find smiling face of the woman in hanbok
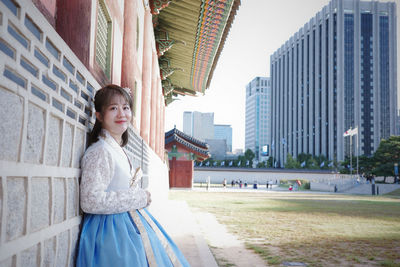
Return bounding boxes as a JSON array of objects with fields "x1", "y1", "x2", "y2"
[{"x1": 96, "y1": 95, "x2": 132, "y2": 144}]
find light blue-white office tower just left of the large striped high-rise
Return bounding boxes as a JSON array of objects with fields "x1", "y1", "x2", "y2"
[{"x1": 245, "y1": 77, "x2": 271, "y2": 160}]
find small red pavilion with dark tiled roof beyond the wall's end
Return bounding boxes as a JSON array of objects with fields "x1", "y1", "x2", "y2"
[{"x1": 165, "y1": 128, "x2": 210, "y2": 188}]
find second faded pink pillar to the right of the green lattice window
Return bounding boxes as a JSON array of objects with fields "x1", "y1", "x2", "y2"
[{"x1": 140, "y1": 10, "x2": 153, "y2": 144}]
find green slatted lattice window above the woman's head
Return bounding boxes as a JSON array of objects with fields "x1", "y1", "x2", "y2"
[{"x1": 96, "y1": 0, "x2": 112, "y2": 78}]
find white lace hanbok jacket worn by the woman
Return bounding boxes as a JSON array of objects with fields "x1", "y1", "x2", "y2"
[{"x1": 80, "y1": 129, "x2": 147, "y2": 214}]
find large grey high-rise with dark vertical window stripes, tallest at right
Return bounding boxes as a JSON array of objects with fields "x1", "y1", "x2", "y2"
[{"x1": 271, "y1": 0, "x2": 397, "y2": 165}]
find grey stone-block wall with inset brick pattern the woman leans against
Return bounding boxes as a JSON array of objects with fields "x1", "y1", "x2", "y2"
[{"x1": 0, "y1": 0, "x2": 168, "y2": 266}]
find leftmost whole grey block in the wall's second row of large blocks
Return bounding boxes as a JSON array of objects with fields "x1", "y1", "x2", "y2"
[{"x1": 5, "y1": 177, "x2": 27, "y2": 241}]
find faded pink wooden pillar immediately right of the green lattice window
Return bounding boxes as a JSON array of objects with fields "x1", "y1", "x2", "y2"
[{"x1": 121, "y1": 1, "x2": 137, "y2": 128}]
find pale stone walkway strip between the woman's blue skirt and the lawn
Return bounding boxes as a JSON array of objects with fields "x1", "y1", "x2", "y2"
[{"x1": 150, "y1": 200, "x2": 218, "y2": 267}]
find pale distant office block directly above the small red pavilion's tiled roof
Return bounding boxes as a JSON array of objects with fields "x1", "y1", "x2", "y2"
[{"x1": 183, "y1": 111, "x2": 214, "y2": 141}]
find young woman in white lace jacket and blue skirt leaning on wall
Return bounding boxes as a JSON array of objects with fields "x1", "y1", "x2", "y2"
[{"x1": 76, "y1": 85, "x2": 189, "y2": 267}]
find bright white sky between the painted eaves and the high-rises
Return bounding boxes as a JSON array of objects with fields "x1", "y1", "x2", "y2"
[{"x1": 165, "y1": 0, "x2": 400, "y2": 150}]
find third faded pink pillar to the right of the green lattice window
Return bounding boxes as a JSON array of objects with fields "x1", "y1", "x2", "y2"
[{"x1": 150, "y1": 51, "x2": 159, "y2": 151}]
